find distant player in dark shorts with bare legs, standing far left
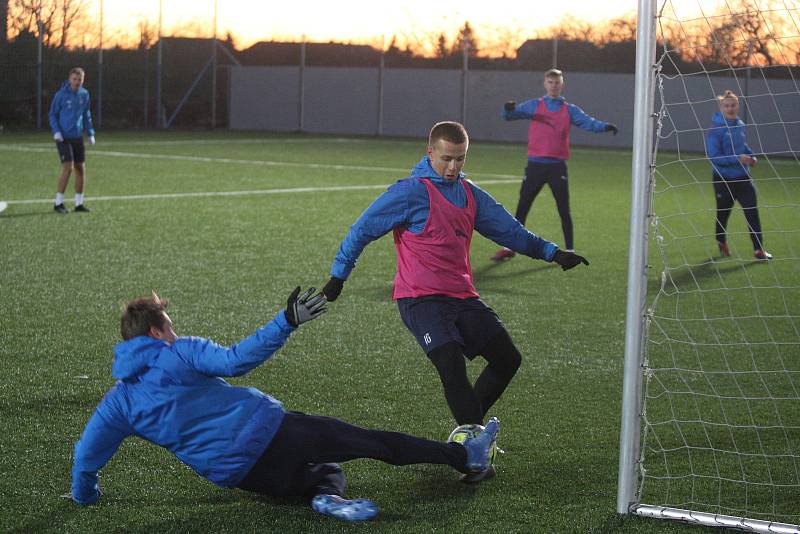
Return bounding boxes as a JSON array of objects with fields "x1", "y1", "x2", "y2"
[{"x1": 48, "y1": 67, "x2": 94, "y2": 215}]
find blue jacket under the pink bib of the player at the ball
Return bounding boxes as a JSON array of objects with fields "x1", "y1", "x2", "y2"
[{"x1": 331, "y1": 156, "x2": 558, "y2": 280}]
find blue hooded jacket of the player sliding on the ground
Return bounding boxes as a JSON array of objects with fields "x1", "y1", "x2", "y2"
[{"x1": 72, "y1": 311, "x2": 294, "y2": 504}]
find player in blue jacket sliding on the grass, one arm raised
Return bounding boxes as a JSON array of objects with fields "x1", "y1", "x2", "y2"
[{"x1": 69, "y1": 294, "x2": 499, "y2": 521}]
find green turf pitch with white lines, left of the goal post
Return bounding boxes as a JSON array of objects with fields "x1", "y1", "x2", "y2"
[{"x1": 0, "y1": 132, "x2": 800, "y2": 532}]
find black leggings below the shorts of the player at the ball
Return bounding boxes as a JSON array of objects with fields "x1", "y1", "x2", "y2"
[{"x1": 428, "y1": 330, "x2": 522, "y2": 425}]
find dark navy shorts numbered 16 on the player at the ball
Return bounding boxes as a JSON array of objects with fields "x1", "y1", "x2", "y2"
[{"x1": 397, "y1": 295, "x2": 505, "y2": 360}]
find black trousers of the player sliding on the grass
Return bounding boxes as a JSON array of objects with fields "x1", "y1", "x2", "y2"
[{"x1": 234, "y1": 412, "x2": 467, "y2": 499}]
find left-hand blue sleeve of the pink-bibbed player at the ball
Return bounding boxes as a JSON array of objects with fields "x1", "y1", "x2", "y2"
[{"x1": 331, "y1": 180, "x2": 411, "y2": 280}]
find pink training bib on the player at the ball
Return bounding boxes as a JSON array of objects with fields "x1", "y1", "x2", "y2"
[{"x1": 392, "y1": 179, "x2": 478, "y2": 300}]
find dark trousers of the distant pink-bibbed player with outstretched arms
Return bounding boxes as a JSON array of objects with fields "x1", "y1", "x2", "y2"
[{"x1": 515, "y1": 161, "x2": 574, "y2": 249}]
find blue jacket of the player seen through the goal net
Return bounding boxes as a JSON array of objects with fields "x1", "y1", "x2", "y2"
[{"x1": 706, "y1": 111, "x2": 753, "y2": 181}]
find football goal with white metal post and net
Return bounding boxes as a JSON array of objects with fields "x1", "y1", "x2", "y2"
[{"x1": 617, "y1": 0, "x2": 800, "y2": 534}]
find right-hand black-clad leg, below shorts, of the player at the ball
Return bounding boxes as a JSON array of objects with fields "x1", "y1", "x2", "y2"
[{"x1": 475, "y1": 329, "x2": 522, "y2": 416}]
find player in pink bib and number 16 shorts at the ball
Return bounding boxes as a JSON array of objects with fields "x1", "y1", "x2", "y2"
[{"x1": 323, "y1": 122, "x2": 589, "y2": 482}]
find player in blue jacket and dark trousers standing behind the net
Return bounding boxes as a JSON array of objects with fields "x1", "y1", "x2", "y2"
[{"x1": 706, "y1": 90, "x2": 772, "y2": 260}]
